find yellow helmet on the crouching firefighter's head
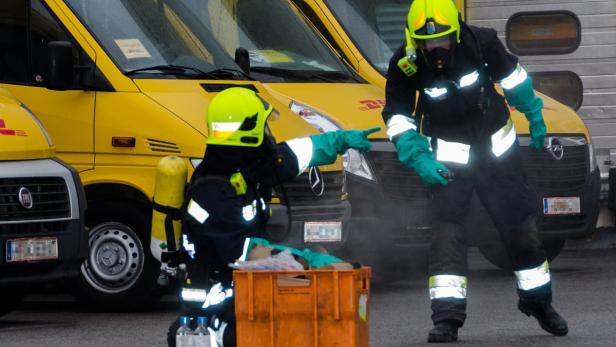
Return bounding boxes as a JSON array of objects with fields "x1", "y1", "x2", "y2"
[{"x1": 207, "y1": 87, "x2": 274, "y2": 147}]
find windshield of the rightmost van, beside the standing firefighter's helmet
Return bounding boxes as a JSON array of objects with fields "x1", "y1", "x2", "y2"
[{"x1": 324, "y1": 0, "x2": 412, "y2": 75}]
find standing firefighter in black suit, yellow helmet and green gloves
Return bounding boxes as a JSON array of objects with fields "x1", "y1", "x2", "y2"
[{"x1": 383, "y1": 0, "x2": 568, "y2": 342}]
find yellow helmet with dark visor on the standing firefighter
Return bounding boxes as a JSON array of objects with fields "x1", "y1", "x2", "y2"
[{"x1": 407, "y1": 0, "x2": 460, "y2": 46}]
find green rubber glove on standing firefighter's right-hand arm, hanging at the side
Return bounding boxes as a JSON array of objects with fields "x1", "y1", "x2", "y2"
[{"x1": 505, "y1": 76, "x2": 547, "y2": 152}]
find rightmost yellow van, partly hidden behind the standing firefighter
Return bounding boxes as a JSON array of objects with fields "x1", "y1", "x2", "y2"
[{"x1": 285, "y1": 0, "x2": 600, "y2": 276}]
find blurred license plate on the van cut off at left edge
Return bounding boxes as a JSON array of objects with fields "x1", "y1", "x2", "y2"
[{"x1": 6, "y1": 237, "x2": 58, "y2": 263}]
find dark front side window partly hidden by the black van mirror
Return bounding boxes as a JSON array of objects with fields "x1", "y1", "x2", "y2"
[{"x1": 30, "y1": 0, "x2": 79, "y2": 84}]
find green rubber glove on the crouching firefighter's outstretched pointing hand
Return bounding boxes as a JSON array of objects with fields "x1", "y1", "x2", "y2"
[{"x1": 308, "y1": 127, "x2": 381, "y2": 166}]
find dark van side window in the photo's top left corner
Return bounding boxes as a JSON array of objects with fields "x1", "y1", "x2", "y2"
[{"x1": 0, "y1": 0, "x2": 28, "y2": 83}]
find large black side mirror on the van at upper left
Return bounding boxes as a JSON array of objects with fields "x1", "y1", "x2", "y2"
[{"x1": 45, "y1": 41, "x2": 75, "y2": 90}]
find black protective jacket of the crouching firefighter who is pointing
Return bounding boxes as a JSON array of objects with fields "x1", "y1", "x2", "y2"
[{"x1": 182, "y1": 143, "x2": 299, "y2": 282}]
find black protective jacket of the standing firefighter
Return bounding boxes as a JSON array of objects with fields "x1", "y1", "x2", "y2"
[{"x1": 383, "y1": 23, "x2": 518, "y2": 148}]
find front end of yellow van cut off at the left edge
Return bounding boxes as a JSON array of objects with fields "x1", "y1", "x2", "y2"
[{"x1": 0, "y1": 88, "x2": 88, "y2": 315}]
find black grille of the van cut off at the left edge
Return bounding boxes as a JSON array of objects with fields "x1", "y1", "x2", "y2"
[{"x1": 0, "y1": 177, "x2": 71, "y2": 222}]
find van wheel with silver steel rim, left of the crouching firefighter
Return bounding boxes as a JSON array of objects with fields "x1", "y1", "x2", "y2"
[{"x1": 73, "y1": 201, "x2": 159, "y2": 311}]
